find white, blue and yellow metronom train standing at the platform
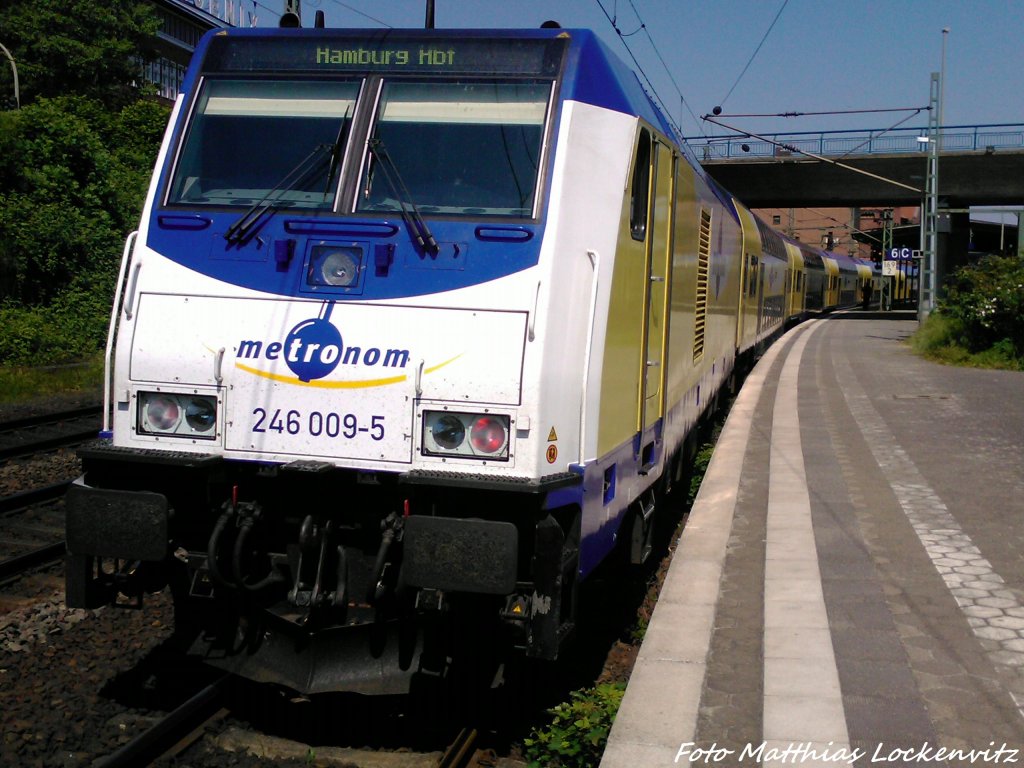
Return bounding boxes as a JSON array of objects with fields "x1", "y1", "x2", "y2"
[{"x1": 67, "y1": 18, "x2": 876, "y2": 693}]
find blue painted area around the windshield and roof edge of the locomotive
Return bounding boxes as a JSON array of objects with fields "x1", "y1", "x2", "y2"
[{"x1": 147, "y1": 29, "x2": 671, "y2": 300}]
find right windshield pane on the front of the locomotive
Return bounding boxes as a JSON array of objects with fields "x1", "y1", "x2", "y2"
[{"x1": 355, "y1": 81, "x2": 551, "y2": 217}]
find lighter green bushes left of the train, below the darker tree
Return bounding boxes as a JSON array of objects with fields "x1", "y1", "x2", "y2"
[{"x1": 0, "y1": 96, "x2": 168, "y2": 365}]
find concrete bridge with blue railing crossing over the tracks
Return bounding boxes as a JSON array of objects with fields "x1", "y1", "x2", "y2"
[{"x1": 687, "y1": 123, "x2": 1024, "y2": 290}]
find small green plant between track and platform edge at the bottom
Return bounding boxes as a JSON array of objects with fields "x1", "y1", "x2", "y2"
[{"x1": 523, "y1": 683, "x2": 626, "y2": 768}]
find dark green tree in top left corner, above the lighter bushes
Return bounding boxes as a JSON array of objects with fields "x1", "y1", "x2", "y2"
[{"x1": 0, "y1": 0, "x2": 160, "y2": 109}]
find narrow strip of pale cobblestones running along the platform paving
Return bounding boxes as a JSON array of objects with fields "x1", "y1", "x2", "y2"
[{"x1": 835, "y1": 350, "x2": 1024, "y2": 717}]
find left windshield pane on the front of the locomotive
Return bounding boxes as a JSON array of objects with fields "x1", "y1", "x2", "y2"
[{"x1": 167, "y1": 80, "x2": 359, "y2": 209}]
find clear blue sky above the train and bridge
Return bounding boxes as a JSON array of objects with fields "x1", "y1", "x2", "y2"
[{"x1": 244, "y1": 0, "x2": 1024, "y2": 143}]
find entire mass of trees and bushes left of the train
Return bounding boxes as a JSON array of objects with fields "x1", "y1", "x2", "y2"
[{"x1": 0, "y1": 0, "x2": 168, "y2": 367}]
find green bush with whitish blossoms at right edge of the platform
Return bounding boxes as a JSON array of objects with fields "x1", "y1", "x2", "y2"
[{"x1": 939, "y1": 256, "x2": 1024, "y2": 357}]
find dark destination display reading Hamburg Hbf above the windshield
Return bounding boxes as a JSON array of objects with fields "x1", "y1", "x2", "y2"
[{"x1": 203, "y1": 35, "x2": 566, "y2": 77}]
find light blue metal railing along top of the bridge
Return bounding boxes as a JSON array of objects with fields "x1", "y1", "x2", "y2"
[{"x1": 686, "y1": 123, "x2": 1024, "y2": 161}]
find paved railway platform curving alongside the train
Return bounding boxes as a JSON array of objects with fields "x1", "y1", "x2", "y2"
[{"x1": 601, "y1": 311, "x2": 1024, "y2": 768}]
